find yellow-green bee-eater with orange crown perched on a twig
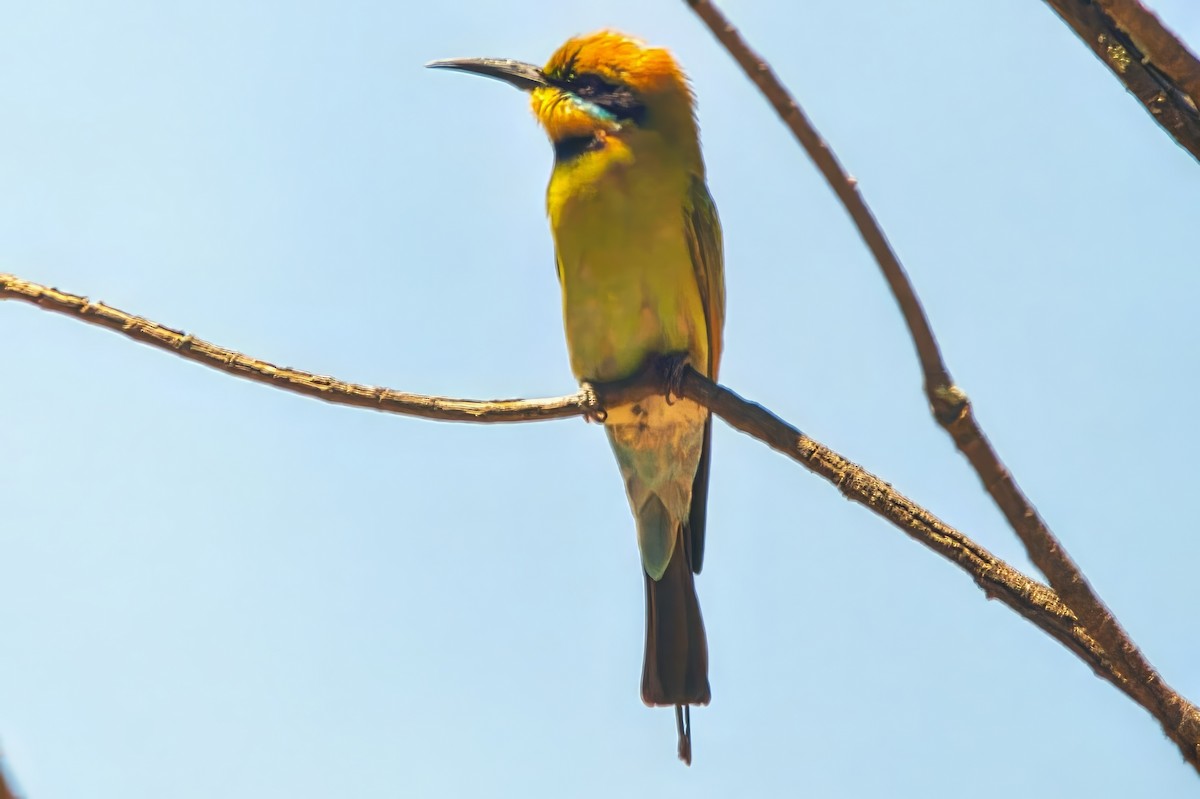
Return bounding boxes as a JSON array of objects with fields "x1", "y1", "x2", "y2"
[{"x1": 428, "y1": 31, "x2": 725, "y2": 763}]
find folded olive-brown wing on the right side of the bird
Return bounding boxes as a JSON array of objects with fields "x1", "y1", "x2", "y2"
[{"x1": 684, "y1": 175, "x2": 725, "y2": 575}]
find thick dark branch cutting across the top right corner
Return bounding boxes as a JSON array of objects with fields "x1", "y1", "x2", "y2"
[{"x1": 1045, "y1": 0, "x2": 1200, "y2": 160}]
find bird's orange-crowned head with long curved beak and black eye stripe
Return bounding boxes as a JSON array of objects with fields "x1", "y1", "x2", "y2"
[{"x1": 427, "y1": 30, "x2": 700, "y2": 158}]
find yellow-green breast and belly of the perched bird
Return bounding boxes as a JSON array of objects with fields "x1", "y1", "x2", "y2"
[{"x1": 547, "y1": 138, "x2": 708, "y2": 382}]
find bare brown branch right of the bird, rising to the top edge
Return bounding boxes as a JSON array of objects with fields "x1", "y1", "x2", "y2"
[{"x1": 685, "y1": 0, "x2": 1200, "y2": 771}]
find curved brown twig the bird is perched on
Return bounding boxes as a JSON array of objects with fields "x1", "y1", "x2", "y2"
[{"x1": 0, "y1": 275, "x2": 1129, "y2": 705}]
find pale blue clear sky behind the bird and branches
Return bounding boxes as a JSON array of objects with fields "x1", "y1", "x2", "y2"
[{"x1": 0, "y1": 0, "x2": 1200, "y2": 799}]
